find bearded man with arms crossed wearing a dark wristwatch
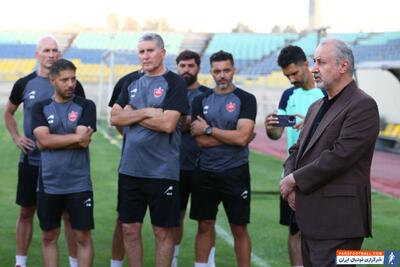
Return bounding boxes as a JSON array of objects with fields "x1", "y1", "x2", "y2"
[{"x1": 190, "y1": 51, "x2": 257, "y2": 267}]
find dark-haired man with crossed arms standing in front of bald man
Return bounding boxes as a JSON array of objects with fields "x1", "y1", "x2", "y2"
[{"x1": 32, "y1": 59, "x2": 96, "y2": 267}]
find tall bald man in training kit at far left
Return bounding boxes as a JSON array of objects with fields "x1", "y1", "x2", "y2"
[{"x1": 4, "y1": 36, "x2": 85, "y2": 267}]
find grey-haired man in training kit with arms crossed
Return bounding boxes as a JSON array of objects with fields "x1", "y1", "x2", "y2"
[{"x1": 111, "y1": 33, "x2": 189, "y2": 267}]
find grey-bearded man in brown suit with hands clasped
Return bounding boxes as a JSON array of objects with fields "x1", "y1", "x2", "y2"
[{"x1": 280, "y1": 40, "x2": 379, "y2": 267}]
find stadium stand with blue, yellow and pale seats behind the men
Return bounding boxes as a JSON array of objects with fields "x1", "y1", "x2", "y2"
[{"x1": 0, "y1": 31, "x2": 400, "y2": 127}]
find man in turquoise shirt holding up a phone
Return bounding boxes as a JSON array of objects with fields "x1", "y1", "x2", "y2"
[{"x1": 265, "y1": 45, "x2": 324, "y2": 266}]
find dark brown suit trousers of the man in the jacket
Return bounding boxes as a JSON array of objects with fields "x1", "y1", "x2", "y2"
[{"x1": 301, "y1": 234, "x2": 364, "y2": 267}]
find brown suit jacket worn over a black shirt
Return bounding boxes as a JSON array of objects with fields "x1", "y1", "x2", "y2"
[{"x1": 285, "y1": 81, "x2": 379, "y2": 239}]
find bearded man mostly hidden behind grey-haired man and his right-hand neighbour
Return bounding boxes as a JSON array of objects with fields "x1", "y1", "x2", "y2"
[{"x1": 172, "y1": 50, "x2": 215, "y2": 267}]
